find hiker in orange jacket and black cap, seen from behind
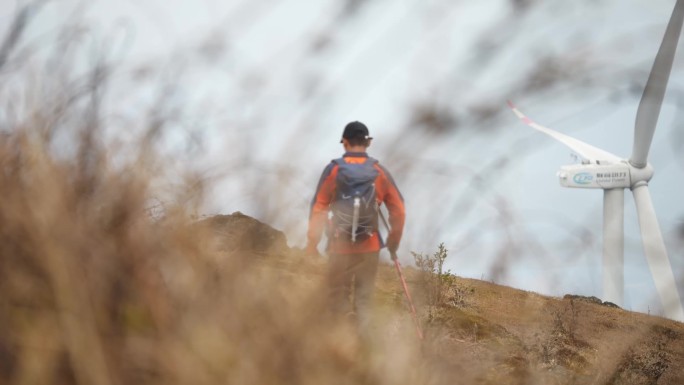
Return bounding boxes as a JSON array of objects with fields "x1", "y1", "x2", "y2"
[{"x1": 306, "y1": 121, "x2": 405, "y2": 332}]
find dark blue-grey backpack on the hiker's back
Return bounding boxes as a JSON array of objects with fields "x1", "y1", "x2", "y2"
[{"x1": 332, "y1": 157, "x2": 378, "y2": 243}]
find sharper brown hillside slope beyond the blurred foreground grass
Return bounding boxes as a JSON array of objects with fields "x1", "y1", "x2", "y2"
[{"x1": 203, "y1": 213, "x2": 684, "y2": 384}]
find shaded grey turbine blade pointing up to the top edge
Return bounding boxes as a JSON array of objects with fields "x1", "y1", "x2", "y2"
[{"x1": 629, "y1": 0, "x2": 684, "y2": 168}]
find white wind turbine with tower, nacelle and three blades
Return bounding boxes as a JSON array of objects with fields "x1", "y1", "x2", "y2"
[{"x1": 508, "y1": 0, "x2": 684, "y2": 321}]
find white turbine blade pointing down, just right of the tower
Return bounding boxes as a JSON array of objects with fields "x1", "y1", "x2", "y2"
[{"x1": 632, "y1": 183, "x2": 684, "y2": 322}]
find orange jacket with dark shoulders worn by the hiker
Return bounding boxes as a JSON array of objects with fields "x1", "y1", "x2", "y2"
[{"x1": 307, "y1": 152, "x2": 406, "y2": 254}]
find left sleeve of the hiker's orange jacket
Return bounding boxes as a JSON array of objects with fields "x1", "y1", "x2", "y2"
[{"x1": 306, "y1": 163, "x2": 337, "y2": 247}]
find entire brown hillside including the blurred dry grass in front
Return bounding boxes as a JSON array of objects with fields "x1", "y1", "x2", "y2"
[{"x1": 0, "y1": 202, "x2": 684, "y2": 385}]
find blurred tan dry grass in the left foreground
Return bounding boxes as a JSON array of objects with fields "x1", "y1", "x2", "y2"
[{"x1": 0, "y1": 91, "x2": 433, "y2": 384}]
